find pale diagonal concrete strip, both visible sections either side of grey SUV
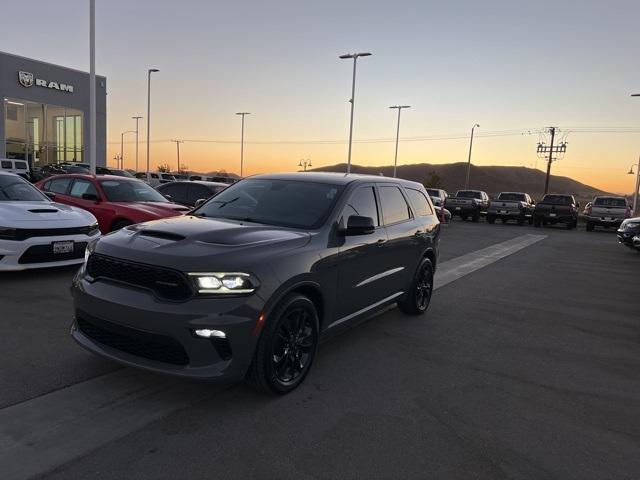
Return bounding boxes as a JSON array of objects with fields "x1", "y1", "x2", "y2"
[{"x1": 0, "y1": 235, "x2": 546, "y2": 480}]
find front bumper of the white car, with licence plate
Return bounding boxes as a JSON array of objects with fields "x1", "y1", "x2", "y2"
[{"x1": 0, "y1": 234, "x2": 98, "y2": 271}]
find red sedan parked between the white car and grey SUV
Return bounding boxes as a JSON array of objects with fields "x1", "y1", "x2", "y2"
[{"x1": 36, "y1": 174, "x2": 189, "y2": 233}]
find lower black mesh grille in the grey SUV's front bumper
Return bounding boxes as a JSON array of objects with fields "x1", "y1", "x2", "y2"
[{"x1": 76, "y1": 314, "x2": 189, "y2": 365}]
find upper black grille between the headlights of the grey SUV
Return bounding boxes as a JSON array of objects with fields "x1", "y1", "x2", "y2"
[{"x1": 87, "y1": 253, "x2": 193, "y2": 301}]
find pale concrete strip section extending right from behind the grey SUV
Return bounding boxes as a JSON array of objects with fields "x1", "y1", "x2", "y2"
[{"x1": 434, "y1": 234, "x2": 547, "y2": 290}]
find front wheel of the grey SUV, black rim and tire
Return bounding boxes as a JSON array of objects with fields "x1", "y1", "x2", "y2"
[{"x1": 247, "y1": 293, "x2": 320, "y2": 395}]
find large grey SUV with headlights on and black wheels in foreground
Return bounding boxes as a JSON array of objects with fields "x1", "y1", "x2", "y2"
[{"x1": 72, "y1": 172, "x2": 440, "y2": 393}]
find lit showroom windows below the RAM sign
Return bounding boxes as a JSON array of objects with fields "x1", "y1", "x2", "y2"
[{"x1": 4, "y1": 98, "x2": 84, "y2": 166}]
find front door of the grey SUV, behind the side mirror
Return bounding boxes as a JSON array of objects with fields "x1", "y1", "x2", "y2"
[{"x1": 335, "y1": 183, "x2": 389, "y2": 322}]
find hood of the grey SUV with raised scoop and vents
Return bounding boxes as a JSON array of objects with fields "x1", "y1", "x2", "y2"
[{"x1": 95, "y1": 215, "x2": 311, "y2": 272}]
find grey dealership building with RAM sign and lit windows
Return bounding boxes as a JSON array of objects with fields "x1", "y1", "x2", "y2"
[{"x1": 0, "y1": 52, "x2": 107, "y2": 166}]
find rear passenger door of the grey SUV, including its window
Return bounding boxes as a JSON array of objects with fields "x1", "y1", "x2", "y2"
[{"x1": 378, "y1": 183, "x2": 427, "y2": 292}]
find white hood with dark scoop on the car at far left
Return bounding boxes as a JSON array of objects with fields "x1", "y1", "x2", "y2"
[{"x1": 0, "y1": 201, "x2": 96, "y2": 228}]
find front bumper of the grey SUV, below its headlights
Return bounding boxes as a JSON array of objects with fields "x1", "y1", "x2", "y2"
[{"x1": 71, "y1": 272, "x2": 264, "y2": 382}]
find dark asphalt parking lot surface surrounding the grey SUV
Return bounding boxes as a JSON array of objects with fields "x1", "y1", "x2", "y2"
[{"x1": 0, "y1": 221, "x2": 640, "y2": 480}]
